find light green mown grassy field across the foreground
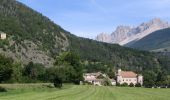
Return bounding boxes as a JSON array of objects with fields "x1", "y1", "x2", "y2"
[{"x1": 0, "y1": 84, "x2": 170, "y2": 100}]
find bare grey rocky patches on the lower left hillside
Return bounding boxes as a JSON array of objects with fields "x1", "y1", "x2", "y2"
[{"x1": 0, "y1": 32, "x2": 69, "y2": 67}]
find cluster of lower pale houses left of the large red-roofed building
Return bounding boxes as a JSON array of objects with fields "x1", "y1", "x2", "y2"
[{"x1": 83, "y1": 72, "x2": 116, "y2": 86}]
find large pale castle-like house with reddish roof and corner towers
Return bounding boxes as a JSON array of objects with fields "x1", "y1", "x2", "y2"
[{"x1": 117, "y1": 69, "x2": 143, "y2": 85}]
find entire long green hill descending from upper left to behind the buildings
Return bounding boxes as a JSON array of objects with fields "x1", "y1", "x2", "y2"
[{"x1": 0, "y1": 0, "x2": 169, "y2": 75}]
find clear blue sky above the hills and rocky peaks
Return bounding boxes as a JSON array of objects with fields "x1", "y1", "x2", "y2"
[{"x1": 18, "y1": 0, "x2": 170, "y2": 39}]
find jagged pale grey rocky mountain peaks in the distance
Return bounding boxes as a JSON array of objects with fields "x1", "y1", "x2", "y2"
[{"x1": 96, "y1": 18, "x2": 170, "y2": 45}]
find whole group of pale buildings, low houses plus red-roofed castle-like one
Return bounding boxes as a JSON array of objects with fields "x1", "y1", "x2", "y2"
[{"x1": 83, "y1": 69, "x2": 143, "y2": 87}]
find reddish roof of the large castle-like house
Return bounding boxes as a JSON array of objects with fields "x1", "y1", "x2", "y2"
[{"x1": 120, "y1": 71, "x2": 137, "y2": 78}]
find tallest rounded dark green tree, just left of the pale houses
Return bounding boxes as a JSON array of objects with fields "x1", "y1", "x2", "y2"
[{"x1": 55, "y1": 52, "x2": 83, "y2": 84}]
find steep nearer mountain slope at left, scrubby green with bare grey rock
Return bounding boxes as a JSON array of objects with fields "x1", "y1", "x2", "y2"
[{"x1": 0, "y1": 0, "x2": 68, "y2": 65}]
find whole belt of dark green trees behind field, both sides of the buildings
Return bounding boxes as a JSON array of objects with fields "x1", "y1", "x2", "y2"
[{"x1": 0, "y1": 52, "x2": 170, "y2": 87}]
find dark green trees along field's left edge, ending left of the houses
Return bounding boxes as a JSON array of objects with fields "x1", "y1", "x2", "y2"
[{"x1": 0, "y1": 52, "x2": 83, "y2": 87}]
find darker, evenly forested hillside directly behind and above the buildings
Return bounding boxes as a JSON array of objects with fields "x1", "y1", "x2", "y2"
[{"x1": 69, "y1": 33, "x2": 159, "y2": 71}]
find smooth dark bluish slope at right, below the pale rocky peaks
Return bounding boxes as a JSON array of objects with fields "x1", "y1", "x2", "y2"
[{"x1": 126, "y1": 28, "x2": 170, "y2": 51}]
